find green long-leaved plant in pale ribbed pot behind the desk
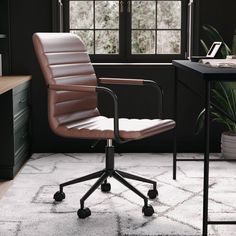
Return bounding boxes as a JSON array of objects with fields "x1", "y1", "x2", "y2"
[{"x1": 196, "y1": 25, "x2": 236, "y2": 159}]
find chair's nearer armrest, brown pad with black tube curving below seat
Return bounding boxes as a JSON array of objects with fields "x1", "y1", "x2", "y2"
[{"x1": 48, "y1": 84, "x2": 126, "y2": 143}]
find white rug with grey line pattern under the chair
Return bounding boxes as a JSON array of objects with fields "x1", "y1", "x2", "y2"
[{"x1": 0, "y1": 153, "x2": 236, "y2": 236}]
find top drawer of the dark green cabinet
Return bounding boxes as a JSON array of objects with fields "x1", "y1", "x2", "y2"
[{"x1": 13, "y1": 87, "x2": 30, "y2": 117}]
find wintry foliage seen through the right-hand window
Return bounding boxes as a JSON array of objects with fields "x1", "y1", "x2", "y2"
[{"x1": 131, "y1": 1, "x2": 181, "y2": 54}]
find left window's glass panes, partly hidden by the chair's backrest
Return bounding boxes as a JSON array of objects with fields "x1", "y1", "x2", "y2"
[{"x1": 69, "y1": 0, "x2": 119, "y2": 54}]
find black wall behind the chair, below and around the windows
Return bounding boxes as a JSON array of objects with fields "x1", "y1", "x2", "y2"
[{"x1": 0, "y1": 0, "x2": 236, "y2": 152}]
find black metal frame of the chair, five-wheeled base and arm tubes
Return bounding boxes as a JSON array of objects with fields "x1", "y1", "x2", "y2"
[{"x1": 53, "y1": 80, "x2": 176, "y2": 218}]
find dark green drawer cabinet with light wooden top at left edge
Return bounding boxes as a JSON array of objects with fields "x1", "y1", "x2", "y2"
[{"x1": 0, "y1": 76, "x2": 30, "y2": 179}]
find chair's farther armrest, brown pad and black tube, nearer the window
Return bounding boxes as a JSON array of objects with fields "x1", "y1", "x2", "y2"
[{"x1": 98, "y1": 78, "x2": 164, "y2": 118}]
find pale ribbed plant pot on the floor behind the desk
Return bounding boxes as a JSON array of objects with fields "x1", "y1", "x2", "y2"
[{"x1": 221, "y1": 132, "x2": 236, "y2": 159}]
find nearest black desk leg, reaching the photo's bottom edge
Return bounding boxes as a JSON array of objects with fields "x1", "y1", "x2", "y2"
[{"x1": 202, "y1": 81, "x2": 211, "y2": 236}]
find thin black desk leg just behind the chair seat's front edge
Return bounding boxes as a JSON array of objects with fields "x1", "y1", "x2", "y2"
[{"x1": 173, "y1": 67, "x2": 178, "y2": 179}]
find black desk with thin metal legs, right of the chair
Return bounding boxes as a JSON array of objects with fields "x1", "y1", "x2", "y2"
[{"x1": 172, "y1": 60, "x2": 236, "y2": 236}]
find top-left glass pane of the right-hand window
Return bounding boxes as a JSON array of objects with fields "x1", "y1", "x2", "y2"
[{"x1": 132, "y1": 1, "x2": 156, "y2": 29}]
